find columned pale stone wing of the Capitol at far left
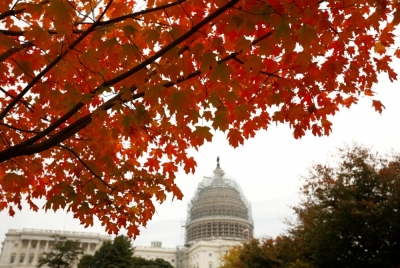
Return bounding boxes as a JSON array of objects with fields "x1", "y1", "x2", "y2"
[{"x1": 0, "y1": 229, "x2": 111, "y2": 268}]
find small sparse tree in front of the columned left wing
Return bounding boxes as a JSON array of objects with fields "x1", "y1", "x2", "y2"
[{"x1": 37, "y1": 236, "x2": 83, "y2": 268}]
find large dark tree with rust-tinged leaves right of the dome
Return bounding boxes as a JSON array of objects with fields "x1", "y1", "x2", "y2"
[{"x1": 221, "y1": 145, "x2": 400, "y2": 268}]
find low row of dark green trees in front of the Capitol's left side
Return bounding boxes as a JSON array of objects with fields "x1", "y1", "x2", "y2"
[{"x1": 37, "y1": 236, "x2": 173, "y2": 268}]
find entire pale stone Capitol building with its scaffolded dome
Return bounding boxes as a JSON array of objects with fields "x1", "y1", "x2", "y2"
[{"x1": 0, "y1": 158, "x2": 254, "y2": 268}]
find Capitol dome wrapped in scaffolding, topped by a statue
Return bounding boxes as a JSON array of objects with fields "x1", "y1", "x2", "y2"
[{"x1": 186, "y1": 165, "x2": 253, "y2": 243}]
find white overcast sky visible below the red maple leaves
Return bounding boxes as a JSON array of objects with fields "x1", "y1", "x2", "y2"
[{"x1": 0, "y1": 64, "x2": 400, "y2": 247}]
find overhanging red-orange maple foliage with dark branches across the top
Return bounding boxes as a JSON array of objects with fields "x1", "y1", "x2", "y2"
[{"x1": 0, "y1": 0, "x2": 400, "y2": 236}]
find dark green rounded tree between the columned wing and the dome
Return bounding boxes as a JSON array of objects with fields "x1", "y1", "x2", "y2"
[{"x1": 78, "y1": 236, "x2": 134, "y2": 268}]
